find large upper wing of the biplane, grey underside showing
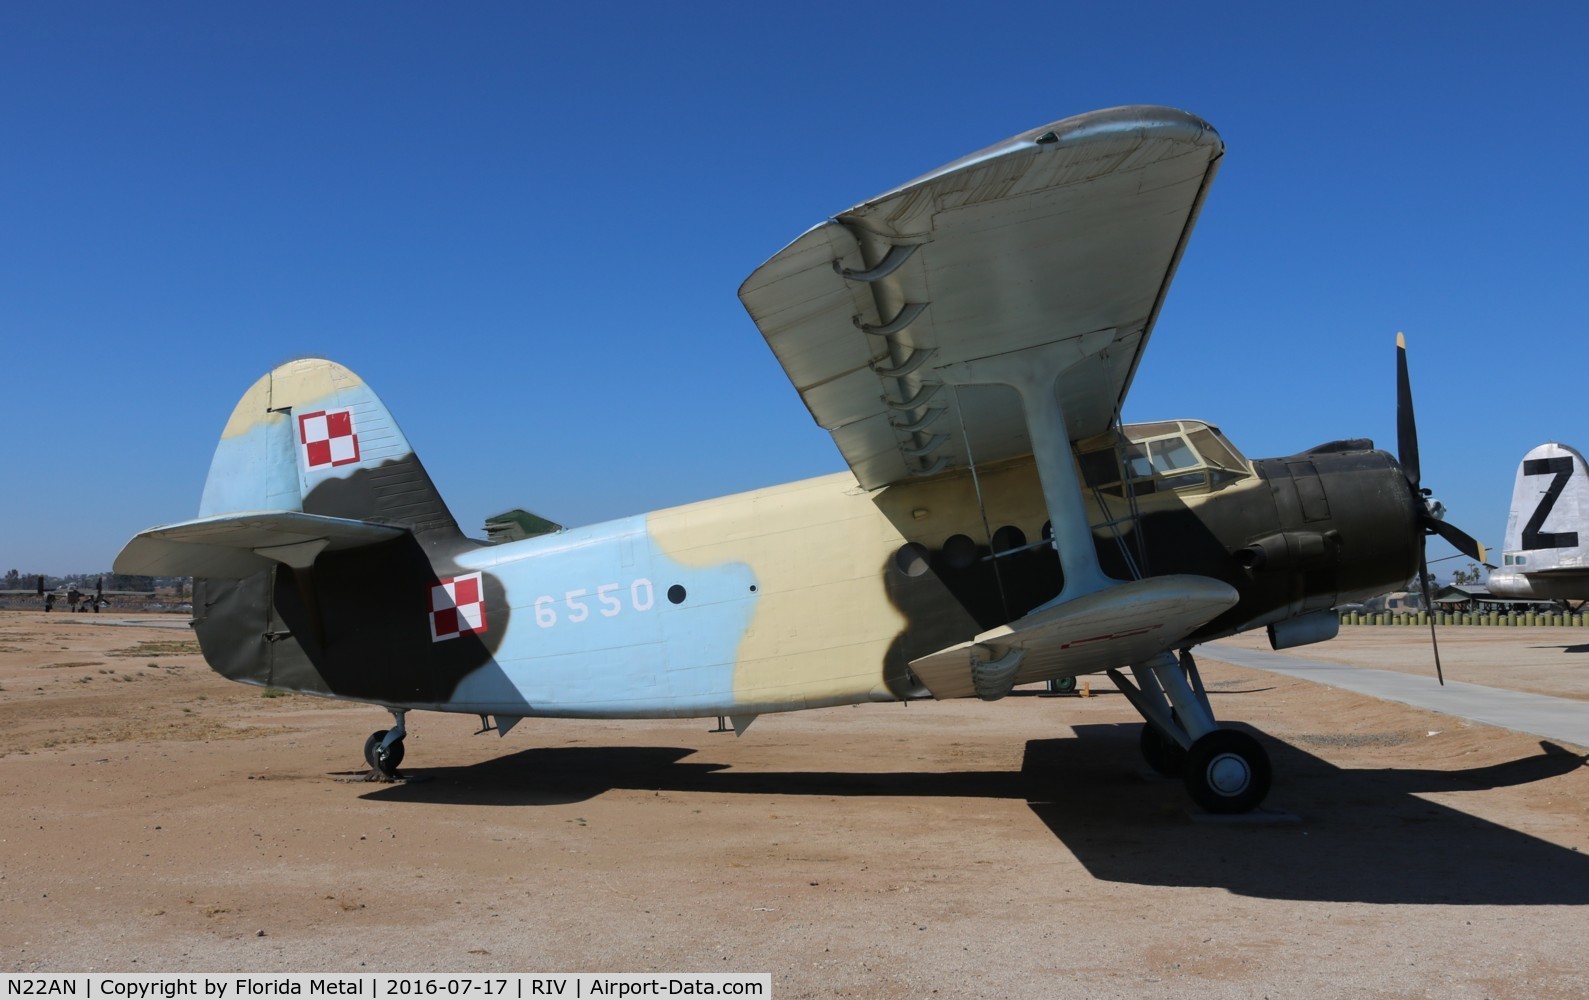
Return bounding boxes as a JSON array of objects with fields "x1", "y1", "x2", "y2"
[{"x1": 739, "y1": 107, "x2": 1225, "y2": 488}]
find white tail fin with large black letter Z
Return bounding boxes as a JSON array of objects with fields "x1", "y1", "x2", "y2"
[{"x1": 1502, "y1": 444, "x2": 1589, "y2": 576}]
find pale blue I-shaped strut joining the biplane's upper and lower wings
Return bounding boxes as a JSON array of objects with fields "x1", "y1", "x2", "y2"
[{"x1": 938, "y1": 328, "x2": 1117, "y2": 614}]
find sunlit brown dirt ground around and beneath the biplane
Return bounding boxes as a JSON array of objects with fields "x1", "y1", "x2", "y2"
[{"x1": 0, "y1": 612, "x2": 1589, "y2": 998}]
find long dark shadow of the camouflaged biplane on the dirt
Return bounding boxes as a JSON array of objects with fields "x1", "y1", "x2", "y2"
[{"x1": 367, "y1": 723, "x2": 1589, "y2": 906}]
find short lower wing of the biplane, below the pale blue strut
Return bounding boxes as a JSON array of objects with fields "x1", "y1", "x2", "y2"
[{"x1": 910, "y1": 576, "x2": 1239, "y2": 700}]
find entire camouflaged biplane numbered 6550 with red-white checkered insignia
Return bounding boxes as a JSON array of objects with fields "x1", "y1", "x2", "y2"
[{"x1": 116, "y1": 107, "x2": 1483, "y2": 812}]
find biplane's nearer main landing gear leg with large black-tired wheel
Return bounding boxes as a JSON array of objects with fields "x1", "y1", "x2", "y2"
[{"x1": 1109, "y1": 650, "x2": 1271, "y2": 812}]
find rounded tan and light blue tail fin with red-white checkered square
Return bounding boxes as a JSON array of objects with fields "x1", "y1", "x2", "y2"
[{"x1": 199, "y1": 358, "x2": 459, "y2": 536}]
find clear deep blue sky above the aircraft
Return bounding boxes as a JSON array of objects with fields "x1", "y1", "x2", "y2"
[{"x1": 0, "y1": 0, "x2": 1589, "y2": 572}]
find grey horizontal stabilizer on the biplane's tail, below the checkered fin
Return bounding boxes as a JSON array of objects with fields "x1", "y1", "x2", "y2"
[{"x1": 114, "y1": 510, "x2": 407, "y2": 580}]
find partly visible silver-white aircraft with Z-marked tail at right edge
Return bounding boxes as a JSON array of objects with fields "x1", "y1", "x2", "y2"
[{"x1": 1487, "y1": 442, "x2": 1589, "y2": 604}]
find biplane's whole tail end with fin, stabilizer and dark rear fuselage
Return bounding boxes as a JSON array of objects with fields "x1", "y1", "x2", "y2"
[{"x1": 116, "y1": 359, "x2": 489, "y2": 704}]
